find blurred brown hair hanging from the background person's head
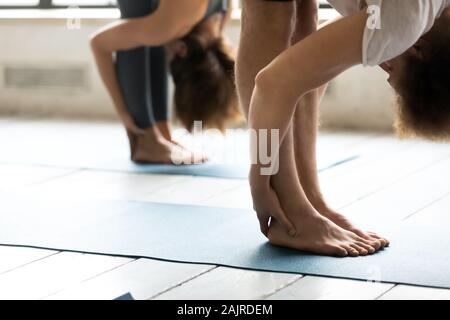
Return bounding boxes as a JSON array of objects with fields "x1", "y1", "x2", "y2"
[{"x1": 170, "y1": 31, "x2": 242, "y2": 131}]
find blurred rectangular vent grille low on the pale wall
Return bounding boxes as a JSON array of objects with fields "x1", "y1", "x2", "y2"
[{"x1": 3, "y1": 66, "x2": 87, "y2": 89}]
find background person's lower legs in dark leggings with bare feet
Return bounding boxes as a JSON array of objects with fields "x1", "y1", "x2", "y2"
[{"x1": 122, "y1": 47, "x2": 206, "y2": 164}]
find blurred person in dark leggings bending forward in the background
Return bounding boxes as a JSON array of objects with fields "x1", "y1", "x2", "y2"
[{"x1": 91, "y1": 0, "x2": 240, "y2": 164}]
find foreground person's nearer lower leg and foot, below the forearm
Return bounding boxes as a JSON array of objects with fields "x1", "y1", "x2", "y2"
[{"x1": 268, "y1": 129, "x2": 378, "y2": 256}]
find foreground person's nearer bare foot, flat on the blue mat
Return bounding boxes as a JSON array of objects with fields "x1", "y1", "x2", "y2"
[{"x1": 268, "y1": 211, "x2": 377, "y2": 257}]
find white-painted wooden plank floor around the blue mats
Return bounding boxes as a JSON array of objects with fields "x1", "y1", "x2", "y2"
[{"x1": 0, "y1": 119, "x2": 450, "y2": 300}]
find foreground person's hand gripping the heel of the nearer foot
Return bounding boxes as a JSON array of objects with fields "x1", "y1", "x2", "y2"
[{"x1": 250, "y1": 166, "x2": 297, "y2": 237}]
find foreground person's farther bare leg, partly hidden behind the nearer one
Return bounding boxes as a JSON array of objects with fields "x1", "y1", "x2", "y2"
[{"x1": 292, "y1": 1, "x2": 389, "y2": 249}]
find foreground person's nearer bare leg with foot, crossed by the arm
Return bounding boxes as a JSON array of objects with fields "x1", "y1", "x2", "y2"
[{"x1": 236, "y1": 0, "x2": 375, "y2": 256}]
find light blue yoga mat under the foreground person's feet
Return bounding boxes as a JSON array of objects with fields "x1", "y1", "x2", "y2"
[{"x1": 0, "y1": 196, "x2": 450, "y2": 288}]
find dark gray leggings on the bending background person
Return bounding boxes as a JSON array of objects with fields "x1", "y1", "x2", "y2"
[{"x1": 116, "y1": 0, "x2": 169, "y2": 129}]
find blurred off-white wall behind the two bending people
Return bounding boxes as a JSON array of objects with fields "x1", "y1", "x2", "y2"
[{"x1": 0, "y1": 13, "x2": 392, "y2": 129}]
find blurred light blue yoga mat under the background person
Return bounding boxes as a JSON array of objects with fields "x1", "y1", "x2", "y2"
[{"x1": 0, "y1": 122, "x2": 358, "y2": 179}]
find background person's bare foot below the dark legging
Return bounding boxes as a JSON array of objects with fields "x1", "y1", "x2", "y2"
[{"x1": 132, "y1": 136, "x2": 207, "y2": 165}]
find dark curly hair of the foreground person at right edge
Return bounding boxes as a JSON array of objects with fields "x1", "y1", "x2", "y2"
[{"x1": 396, "y1": 21, "x2": 450, "y2": 141}]
